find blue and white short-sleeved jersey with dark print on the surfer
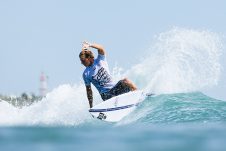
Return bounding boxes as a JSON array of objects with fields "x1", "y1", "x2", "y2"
[{"x1": 83, "y1": 54, "x2": 116, "y2": 93}]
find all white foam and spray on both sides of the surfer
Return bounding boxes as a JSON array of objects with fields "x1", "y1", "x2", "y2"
[{"x1": 0, "y1": 27, "x2": 222, "y2": 126}]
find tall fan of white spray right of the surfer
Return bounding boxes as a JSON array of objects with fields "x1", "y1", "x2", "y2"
[{"x1": 125, "y1": 28, "x2": 222, "y2": 93}]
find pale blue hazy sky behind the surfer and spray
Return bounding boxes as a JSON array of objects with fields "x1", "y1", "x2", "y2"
[{"x1": 0, "y1": 0, "x2": 226, "y2": 100}]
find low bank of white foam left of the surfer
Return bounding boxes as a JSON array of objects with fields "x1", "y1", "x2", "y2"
[{"x1": 0, "y1": 84, "x2": 91, "y2": 126}]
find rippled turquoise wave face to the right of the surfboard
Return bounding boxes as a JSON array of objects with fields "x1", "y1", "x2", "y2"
[{"x1": 119, "y1": 92, "x2": 226, "y2": 125}]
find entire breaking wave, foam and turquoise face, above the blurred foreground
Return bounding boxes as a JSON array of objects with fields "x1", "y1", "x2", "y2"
[{"x1": 0, "y1": 28, "x2": 226, "y2": 126}]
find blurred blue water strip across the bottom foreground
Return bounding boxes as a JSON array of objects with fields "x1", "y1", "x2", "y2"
[{"x1": 0, "y1": 125, "x2": 226, "y2": 151}]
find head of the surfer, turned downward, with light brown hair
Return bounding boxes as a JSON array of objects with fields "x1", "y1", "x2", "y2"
[{"x1": 79, "y1": 50, "x2": 94, "y2": 67}]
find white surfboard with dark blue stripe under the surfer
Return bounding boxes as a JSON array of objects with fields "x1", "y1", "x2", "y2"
[{"x1": 89, "y1": 91, "x2": 151, "y2": 122}]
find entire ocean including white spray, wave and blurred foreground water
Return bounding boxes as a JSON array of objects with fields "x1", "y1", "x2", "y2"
[{"x1": 0, "y1": 28, "x2": 226, "y2": 151}]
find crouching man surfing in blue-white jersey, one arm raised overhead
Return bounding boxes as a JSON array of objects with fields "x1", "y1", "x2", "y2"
[{"x1": 79, "y1": 42, "x2": 137, "y2": 108}]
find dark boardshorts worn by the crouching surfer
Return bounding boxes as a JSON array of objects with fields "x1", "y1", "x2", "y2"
[{"x1": 100, "y1": 80, "x2": 131, "y2": 101}]
